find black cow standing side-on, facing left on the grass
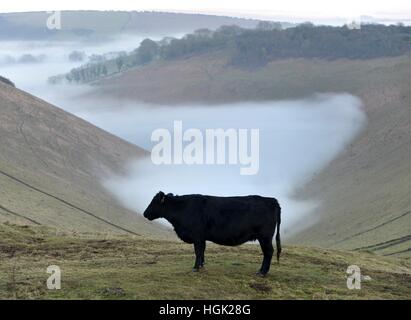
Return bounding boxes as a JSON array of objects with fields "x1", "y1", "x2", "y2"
[{"x1": 144, "y1": 191, "x2": 281, "y2": 276}]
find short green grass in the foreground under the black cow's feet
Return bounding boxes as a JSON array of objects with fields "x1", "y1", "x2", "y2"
[{"x1": 0, "y1": 224, "x2": 411, "y2": 299}]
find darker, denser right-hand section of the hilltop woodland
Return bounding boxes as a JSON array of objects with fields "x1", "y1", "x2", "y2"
[{"x1": 232, "y1": 24, "x2": 411, "y2": 66}]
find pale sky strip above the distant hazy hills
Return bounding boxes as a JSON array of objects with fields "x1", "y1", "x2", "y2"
[{"x1": 0, "y1": 0, "x2": 411, "y2": 20}]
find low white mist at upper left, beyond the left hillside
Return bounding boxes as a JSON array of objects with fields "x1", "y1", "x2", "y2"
[{"x1": 0, "y1": 34, "x2": 182, "y2": 96}]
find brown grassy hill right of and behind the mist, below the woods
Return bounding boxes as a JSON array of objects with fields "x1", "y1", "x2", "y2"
[{"x1": 91, "y1": 53, "x2": 411, "y2": 256}]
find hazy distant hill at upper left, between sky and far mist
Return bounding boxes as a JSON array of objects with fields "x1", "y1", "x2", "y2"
[{"x1": 0, "y1": 11, "x2": 264, "y2": 40}]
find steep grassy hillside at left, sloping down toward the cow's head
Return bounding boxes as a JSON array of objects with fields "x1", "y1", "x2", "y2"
[{"x1": 0, "y1": 82, "x2": 169, "y2": 241}]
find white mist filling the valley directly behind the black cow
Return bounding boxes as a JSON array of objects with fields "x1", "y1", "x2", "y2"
[{"x1": 71, "y1": 94, "x2": 365, "y2": 235}]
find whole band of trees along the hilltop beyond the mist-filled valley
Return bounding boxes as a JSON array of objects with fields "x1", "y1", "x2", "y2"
[{"x1": 49, "y1": 22, "x2": 411, "y2": 82}]
